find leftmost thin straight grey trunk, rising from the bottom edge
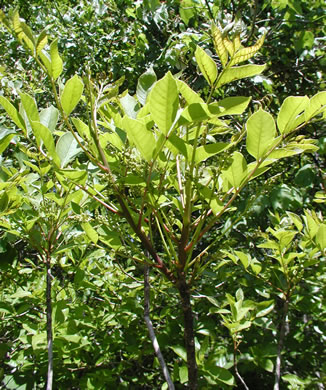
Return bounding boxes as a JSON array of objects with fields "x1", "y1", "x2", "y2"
[{"x1": 46, "y1": 256, "x2": 53, "y2": 390}]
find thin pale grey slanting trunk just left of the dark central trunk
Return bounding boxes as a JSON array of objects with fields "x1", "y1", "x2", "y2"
[{"x1": 144, "y1": 265, "x2": 174, "y2": 390}]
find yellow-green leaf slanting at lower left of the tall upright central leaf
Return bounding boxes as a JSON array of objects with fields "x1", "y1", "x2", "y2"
[{"x1": 122, "y1": 116, "x2": 155, "y2": 161}]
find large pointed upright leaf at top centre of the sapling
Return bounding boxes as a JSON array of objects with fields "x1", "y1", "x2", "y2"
[{"x1": 148, "y1": 72, "x2": 179, "y2": 135}]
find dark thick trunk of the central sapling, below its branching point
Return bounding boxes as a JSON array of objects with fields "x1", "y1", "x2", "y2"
[{"x1": 177, "y1": 273, "x2": 198, "y2": 390}]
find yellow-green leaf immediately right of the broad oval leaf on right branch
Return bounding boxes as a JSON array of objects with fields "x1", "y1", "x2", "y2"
[{"x1": 277, "y1": 96, "x2": 309, "y2": 134}]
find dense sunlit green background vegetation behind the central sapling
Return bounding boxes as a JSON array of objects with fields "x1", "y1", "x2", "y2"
[{"x1": 0, "y1": 0, "x2": 326, "y2": 390}]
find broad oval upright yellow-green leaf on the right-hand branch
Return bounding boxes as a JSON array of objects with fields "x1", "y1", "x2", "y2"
[{"x1": 246, "y1": 110, "x2": 276, "y2": 160}]
